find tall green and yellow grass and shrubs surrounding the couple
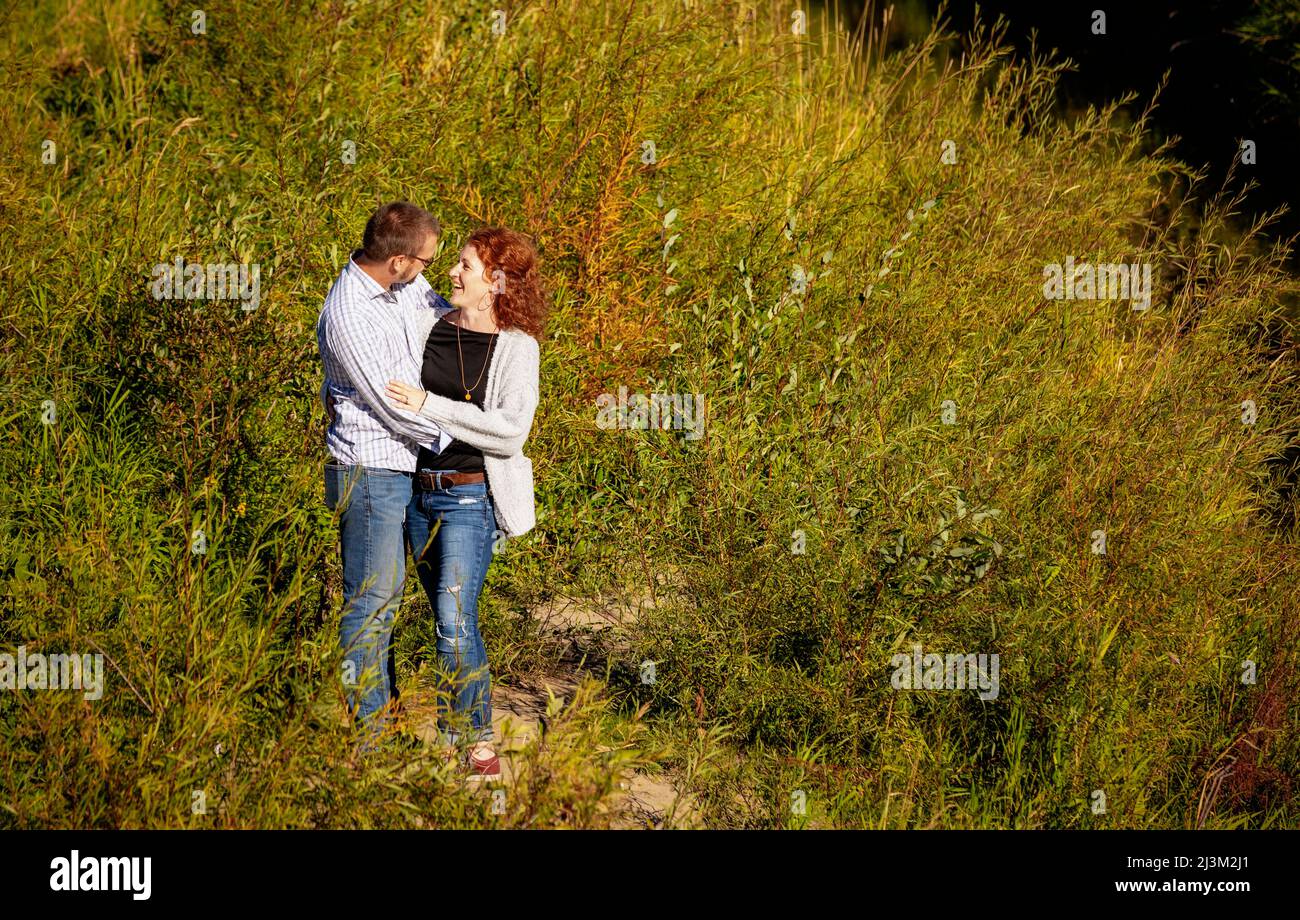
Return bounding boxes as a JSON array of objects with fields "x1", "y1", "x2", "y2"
[{"x1": 0, "y1": 0, "x2": 1300, "y2": 828}]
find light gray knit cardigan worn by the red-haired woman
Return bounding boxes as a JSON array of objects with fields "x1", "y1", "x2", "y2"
[{"x1": 420, "y1": 309, "x2": 541, "y2": 537}]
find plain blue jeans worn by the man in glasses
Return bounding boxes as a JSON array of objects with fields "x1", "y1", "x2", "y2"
[{"x1": 325, "y1": 463, "x2": 412, "y2": 743}]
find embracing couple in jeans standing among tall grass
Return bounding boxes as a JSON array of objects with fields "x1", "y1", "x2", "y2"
[{"x1": 316, "y1": 201, "x2": 545, "y2": 777}]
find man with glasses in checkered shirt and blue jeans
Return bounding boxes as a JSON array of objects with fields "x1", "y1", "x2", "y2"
[{"x1": 316, "y1": 201, "x2": 452, "y2": 748}]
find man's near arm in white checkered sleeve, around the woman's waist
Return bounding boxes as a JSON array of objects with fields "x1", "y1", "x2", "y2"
[{"x1": 325, "y1": 311, "x2": 452, "y2": 454}]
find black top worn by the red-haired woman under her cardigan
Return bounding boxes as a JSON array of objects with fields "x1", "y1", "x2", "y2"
[{"x1": 416, "y1": 318, "x2": 497, "y2": 473}]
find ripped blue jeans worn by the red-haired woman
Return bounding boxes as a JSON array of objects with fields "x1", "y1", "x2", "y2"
[{"x1": 406, "y1": 470, "x2": 498, "y2": 743}]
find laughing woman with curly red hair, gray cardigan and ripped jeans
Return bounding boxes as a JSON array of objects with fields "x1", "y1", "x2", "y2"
[{"x1": 387, "y1": 227, "x2": 545, "y2": 777}]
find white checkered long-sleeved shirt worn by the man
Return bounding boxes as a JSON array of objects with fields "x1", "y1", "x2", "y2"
[{"x1": 316, "y1": 249, "x2": 452, "y2": 472}]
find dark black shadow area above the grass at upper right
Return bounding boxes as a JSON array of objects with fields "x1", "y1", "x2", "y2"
[{"x1": 827, "y1": 0, "x2": 1300, "y2": 270}]
